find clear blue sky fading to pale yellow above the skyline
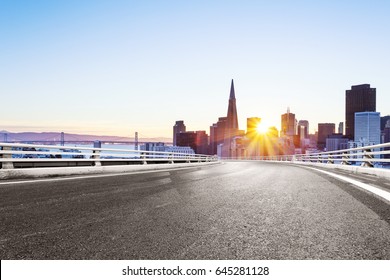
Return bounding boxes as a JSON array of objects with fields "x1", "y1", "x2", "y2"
[{"x1": 0, "y1": 0, "x2": 390, "y2": 137}]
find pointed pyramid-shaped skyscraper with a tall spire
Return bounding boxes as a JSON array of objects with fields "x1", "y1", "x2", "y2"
[{"x1": 222, "y1": 80, "x2": 240, "y2": 157}]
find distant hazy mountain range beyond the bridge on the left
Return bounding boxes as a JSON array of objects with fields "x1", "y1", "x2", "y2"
[{"x1": 0, "y1": 130, "x2": 172, "y2": 143}]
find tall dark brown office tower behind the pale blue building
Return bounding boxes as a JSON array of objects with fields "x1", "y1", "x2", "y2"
[{"x1": 345, "y1": 84, "x2": 376, "y2": 140}]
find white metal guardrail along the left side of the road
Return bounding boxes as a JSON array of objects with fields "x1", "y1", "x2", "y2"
[{"x1": 0, "y1": 143, "x2": 218, "y2": 169}]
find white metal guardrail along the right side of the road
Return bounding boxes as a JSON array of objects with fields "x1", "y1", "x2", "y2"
[{"x1": 224, "y1": 142, "x2": 390, "y2": 167}]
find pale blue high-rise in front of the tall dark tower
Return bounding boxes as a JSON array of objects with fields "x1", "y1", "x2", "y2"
[{"x1": 354, "y1": 112, "x2": 381, "y2": 145}]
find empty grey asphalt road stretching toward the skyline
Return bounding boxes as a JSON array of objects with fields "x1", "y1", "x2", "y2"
[{"x1": 0, "y1": 162, "x2": 390, "y2": 260}]
